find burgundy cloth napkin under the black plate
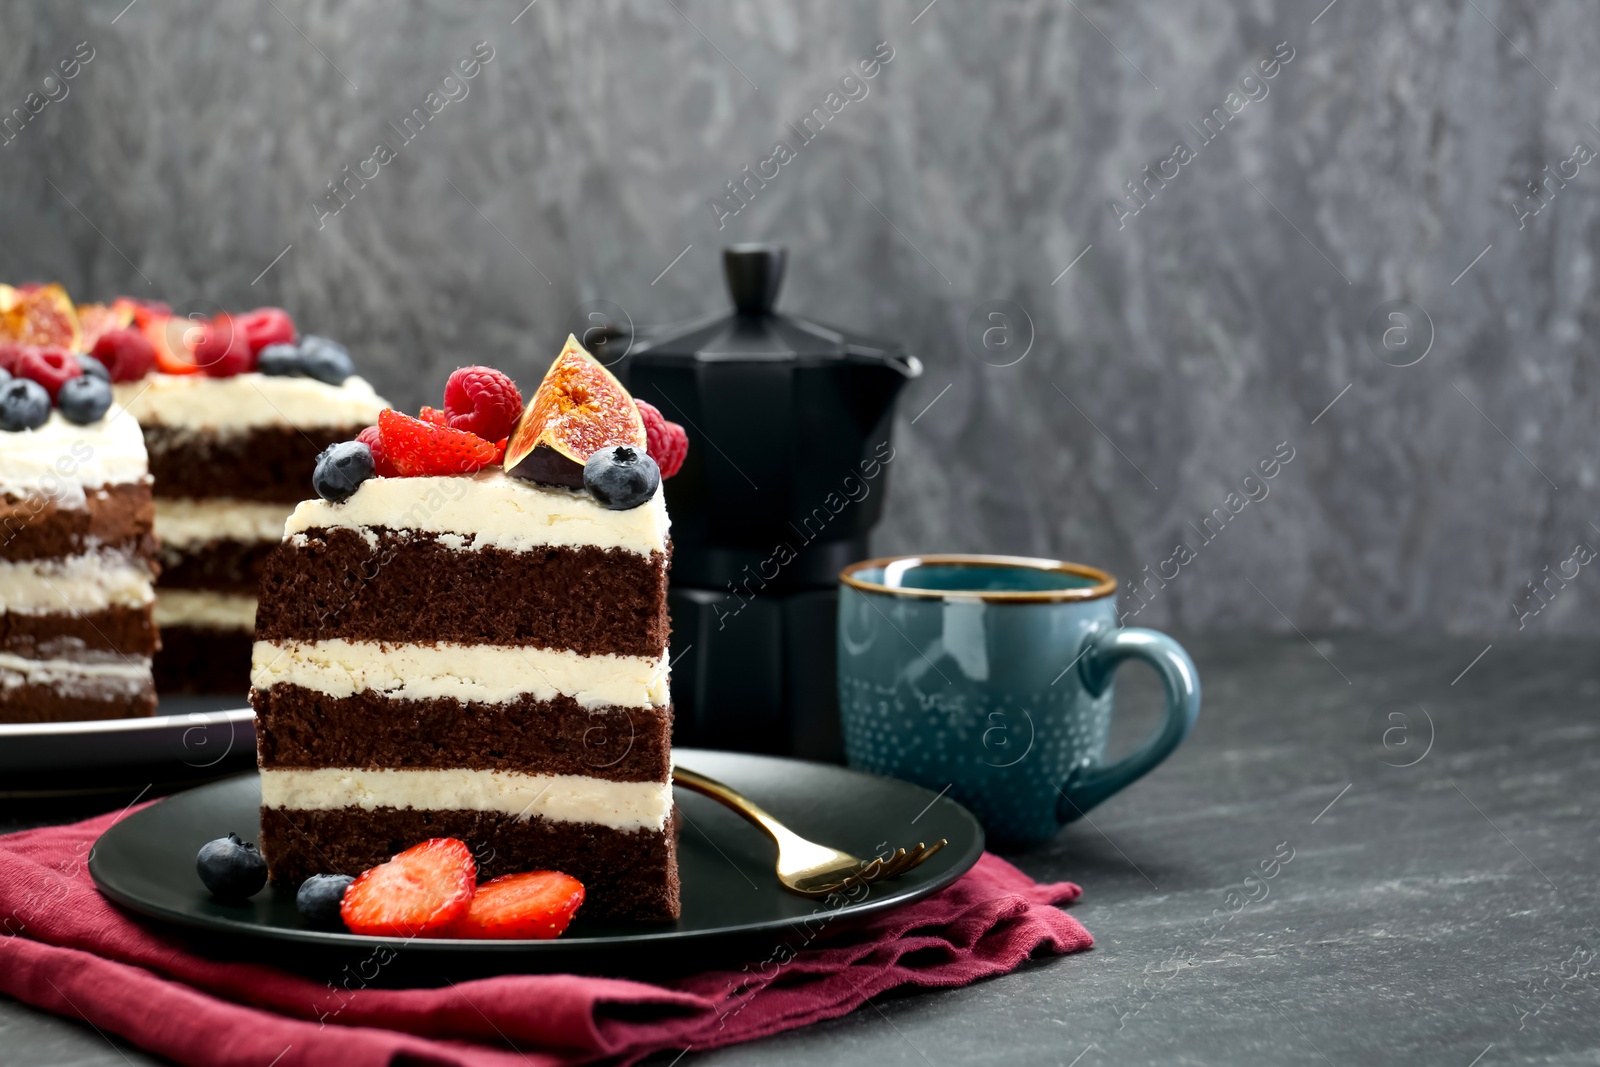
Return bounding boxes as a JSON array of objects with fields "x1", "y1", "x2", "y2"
[{"x1": 0, "y1": 814, "x2": 1093, "y2": 1067}]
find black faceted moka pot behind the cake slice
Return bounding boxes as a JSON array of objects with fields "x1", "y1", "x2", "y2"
[{"x1": 627, "y1": 245, "x2": 922, "y2": 761}]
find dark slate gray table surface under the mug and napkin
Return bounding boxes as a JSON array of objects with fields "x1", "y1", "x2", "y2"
[{"x1": 0, "y1": 637, "x2": 1600, "y2": 1067}]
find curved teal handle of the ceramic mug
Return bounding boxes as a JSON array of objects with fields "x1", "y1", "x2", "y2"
[{"x1": 1056, "y1": 627, "x2": 1200, "y2": 824}]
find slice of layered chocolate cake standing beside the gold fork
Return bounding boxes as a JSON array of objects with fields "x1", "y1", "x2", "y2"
[{"x1": 251, "y1": 349, "x2": 678, "y2": 920}]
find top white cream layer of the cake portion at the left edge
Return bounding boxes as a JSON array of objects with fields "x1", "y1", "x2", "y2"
[{"x1": 0, "y1": 405, "x2": 149, "y2": 507}]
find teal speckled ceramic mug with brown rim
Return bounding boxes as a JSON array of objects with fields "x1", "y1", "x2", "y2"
[{"x1": 838, "y1": 555, "x2": 1200, "y2": 845}]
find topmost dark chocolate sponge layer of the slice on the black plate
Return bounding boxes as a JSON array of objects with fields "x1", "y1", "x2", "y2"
[{"x1": 256, "y1": 526, "x2": 669, "y2": 657}]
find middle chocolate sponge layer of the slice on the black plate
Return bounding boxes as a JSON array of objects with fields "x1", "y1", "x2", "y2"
[{"x1": 251, "y1": 681, "x2": 672, "y2": 782}]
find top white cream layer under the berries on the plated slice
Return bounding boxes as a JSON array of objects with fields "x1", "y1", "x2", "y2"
[{"x1": 283, "y1": 469, "x2": 670, "y2": 555}]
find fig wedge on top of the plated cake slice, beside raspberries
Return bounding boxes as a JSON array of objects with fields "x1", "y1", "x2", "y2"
[{"x1": 506, "y1": 334, "x2": 645, "y2": 490}]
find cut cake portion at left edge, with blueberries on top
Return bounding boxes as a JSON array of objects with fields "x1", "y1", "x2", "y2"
[{"x1": 0, "y1": 395, "x2": 157, "y2": 723}]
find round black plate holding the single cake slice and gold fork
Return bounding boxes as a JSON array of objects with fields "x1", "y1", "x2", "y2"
[{"x1": 90, "y1": 749, "x2": 984, "y2": 969}]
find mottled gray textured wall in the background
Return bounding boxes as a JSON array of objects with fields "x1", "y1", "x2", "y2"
[{"x1": 0, "y1": 0, "x2": 1600, "y2": 637}]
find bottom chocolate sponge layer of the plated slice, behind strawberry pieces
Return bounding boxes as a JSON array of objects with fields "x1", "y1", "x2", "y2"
[{"x1": 261, "y1": 808, "x2": 680, "y2": 920}]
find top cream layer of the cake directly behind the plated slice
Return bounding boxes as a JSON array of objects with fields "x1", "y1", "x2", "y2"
[{"x1": 112, "y1": 371, "x2": 389, "y2": 434}]
